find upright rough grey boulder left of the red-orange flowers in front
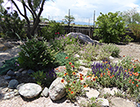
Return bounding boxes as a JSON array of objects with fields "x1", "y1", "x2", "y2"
[{"x1": 49, "y1": 77, "x2": 67, "y2": 101}]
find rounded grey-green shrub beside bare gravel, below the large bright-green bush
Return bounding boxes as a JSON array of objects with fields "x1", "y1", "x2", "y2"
[{"x1": 102, "y1": 44, "x2": 120, "y2": 57}]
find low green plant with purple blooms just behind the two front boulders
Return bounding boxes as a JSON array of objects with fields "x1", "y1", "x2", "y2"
[{"x1": 31, "y1": 70, "x2": 56, "y2": 88}]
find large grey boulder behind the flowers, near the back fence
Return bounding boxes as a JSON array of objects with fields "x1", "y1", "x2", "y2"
[{"x1": 67, "y1": 32, "x2": 100, "y2": 44}]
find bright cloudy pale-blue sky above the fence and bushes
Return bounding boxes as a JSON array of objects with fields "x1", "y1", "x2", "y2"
[{"x1": 4, "y1": 0, "x2": 140, "y2": 23}]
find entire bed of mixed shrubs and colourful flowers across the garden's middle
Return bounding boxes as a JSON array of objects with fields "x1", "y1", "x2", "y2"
[{"x1": 0, "y1": 35, "x2": 140, "y2": 105}]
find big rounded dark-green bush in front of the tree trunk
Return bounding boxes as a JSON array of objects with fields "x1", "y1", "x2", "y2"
[{"x1": 18, "y1": 38, "x2": 55, "y2": 70}]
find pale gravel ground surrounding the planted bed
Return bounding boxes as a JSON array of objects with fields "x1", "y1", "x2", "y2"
[{"x1": 0, "y1": 43, "x2": 140, "y2": 107}]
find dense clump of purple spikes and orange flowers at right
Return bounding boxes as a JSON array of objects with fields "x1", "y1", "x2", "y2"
[{"x1": 91, "y1": 60, "x2": 140, "y2": 96}]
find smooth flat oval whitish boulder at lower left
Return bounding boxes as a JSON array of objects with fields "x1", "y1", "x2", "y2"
[{"x1": 18, "y1": 83, "x2": 42, "y2": 98}]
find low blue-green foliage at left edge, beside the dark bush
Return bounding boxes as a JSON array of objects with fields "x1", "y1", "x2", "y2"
[{"x1": 0, "y1": 57, "x2": 19, "y2": 75}]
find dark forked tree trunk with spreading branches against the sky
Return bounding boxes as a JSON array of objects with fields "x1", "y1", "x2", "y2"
[{"x1": 9, "y1": 0, "x2": 52, "y2": 38}]
